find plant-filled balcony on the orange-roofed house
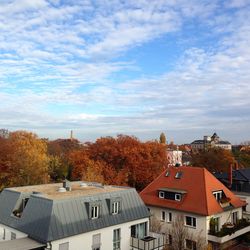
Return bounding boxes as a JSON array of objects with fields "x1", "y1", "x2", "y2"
[{"x1": 208, "y1": 219, "x2": 250, "y2": 244}]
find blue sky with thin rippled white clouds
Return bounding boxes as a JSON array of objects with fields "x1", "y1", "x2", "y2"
[{"x1": 0, "y1": 0, "x2": 250, "y2": 143}]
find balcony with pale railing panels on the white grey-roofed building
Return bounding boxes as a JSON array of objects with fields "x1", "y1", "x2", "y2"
[{"x1": 130, "y1": 232, "x2": 167, "y2": 250}]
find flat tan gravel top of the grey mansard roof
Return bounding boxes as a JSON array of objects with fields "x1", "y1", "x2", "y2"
[{"x1": 8, "y1": 181, "x2": 126, "y2": 200}]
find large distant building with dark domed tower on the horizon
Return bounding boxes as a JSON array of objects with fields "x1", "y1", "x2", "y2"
[{"x1": 191, "y1": 133, "x2": 232, "y2": 152}]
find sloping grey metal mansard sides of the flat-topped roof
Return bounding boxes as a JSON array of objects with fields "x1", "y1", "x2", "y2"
[{"x1": 0, "y1": 188, "x2": 149, "y2": 243}]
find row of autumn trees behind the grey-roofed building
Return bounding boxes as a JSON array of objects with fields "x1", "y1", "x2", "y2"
[{"x1": 0, "y1": 129, "x2": 167, "y2": 190}]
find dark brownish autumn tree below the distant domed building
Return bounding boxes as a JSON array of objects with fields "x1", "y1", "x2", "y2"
[{"x1": 191, "y1": 148, "x2": 235, "y2": 172}]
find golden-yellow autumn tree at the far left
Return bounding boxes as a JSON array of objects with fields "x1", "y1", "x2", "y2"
[{"x1": 0, "y1": 131, "x2": 48, "y2": 187}]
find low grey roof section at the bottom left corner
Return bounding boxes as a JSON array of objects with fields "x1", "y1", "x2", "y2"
[{"x1": 0, "y1": 238, "x2": 46, "y2": 250}]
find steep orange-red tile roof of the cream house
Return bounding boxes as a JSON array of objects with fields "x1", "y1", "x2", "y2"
[{"x1": 140, "y1": 166, "x2": 246, "y2": 215}]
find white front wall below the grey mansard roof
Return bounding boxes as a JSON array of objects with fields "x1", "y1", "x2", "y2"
[{"x1": 51, "y1": 218, "x2": 149, "y2": 250}]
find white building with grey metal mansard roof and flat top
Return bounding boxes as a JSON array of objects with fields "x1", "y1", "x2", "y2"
[{"x1": 0, "y1": 182, "x2": 166, "y2": 250}]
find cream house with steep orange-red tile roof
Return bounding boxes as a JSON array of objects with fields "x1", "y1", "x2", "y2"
[{"x1": 140, "y1": 166, "x2": 250, "y2": 249}]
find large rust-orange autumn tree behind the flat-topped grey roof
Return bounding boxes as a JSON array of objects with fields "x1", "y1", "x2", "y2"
[{"x1": 70, "y1": 135, "x2": 167, "y2": 190}]
